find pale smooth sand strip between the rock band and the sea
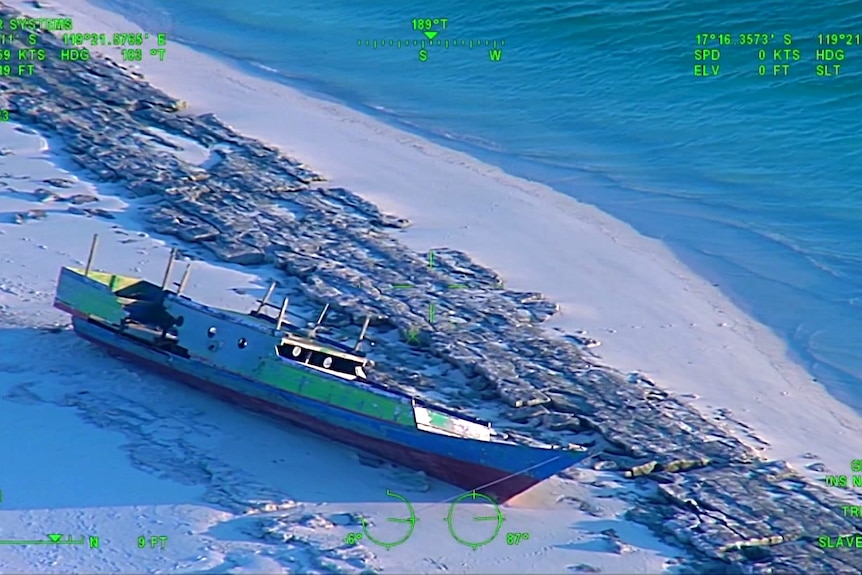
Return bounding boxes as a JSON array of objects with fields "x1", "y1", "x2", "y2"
[{"x1": 22, "y1": 0, "x2": 862, "y2": 476}]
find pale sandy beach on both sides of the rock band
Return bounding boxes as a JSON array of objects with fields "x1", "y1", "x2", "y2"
[{"x1": 0, "y1": 0, "x2": 862, "y2": 573}]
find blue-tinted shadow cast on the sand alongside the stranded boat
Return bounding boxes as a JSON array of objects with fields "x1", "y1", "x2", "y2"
[{"x1": 0, "y1": 326, "x2": 472, "y2": 513}]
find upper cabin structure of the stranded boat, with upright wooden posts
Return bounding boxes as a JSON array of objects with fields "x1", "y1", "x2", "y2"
[{"x1": 54, "y1": 237, "x2": 493, "y2": 441}]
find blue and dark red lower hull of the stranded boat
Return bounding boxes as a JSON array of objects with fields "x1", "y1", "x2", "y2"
[{"x1": 67, "y1": 317, "x2": 583, "y2": 502}]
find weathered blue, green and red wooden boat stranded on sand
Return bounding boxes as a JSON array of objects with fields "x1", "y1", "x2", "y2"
[{"x1": 54, "y1": 238, "x2": 587, "y2": 502}]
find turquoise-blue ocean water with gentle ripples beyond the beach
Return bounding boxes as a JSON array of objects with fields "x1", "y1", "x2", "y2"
[{"x1": 98, "y1": 0, "x2": 862, "y2": 410}]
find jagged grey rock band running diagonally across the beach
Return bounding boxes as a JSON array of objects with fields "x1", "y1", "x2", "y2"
[{"x1": 0, "y1": 8, "x2": 862, "y2": 573}]
